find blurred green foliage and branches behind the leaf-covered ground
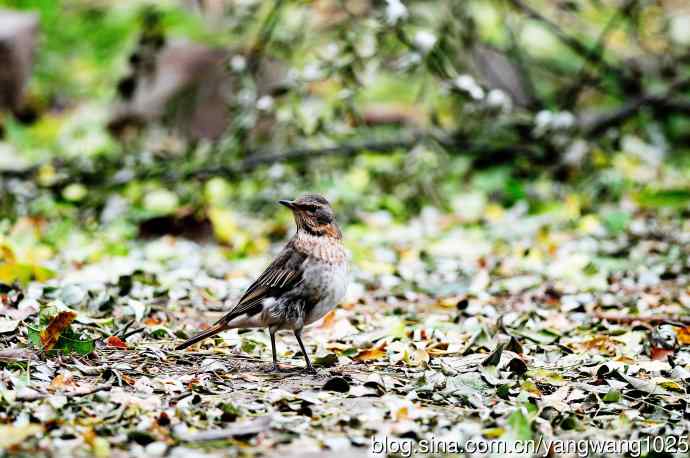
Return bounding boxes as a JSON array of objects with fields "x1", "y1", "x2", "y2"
[{"x1": 0, "y1": 0, "x2": 690, "y2": 247}]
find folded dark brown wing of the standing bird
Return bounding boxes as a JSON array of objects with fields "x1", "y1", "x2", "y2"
[{"x1": 218, "y1": 243, "x2": 307, "y2": 323}]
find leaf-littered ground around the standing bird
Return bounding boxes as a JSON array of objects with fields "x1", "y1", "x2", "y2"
[{"x1": 0, "y1": 188, "x2": 690, "y2": 457}]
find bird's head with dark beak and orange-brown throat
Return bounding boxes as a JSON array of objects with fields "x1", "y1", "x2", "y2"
[{"x1": 279, "y1": 194, "x2": 342, "y2": 239}]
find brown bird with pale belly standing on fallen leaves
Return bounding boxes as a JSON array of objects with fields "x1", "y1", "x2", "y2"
[{"x1": 176, "y1": 194, "x2": 349, "y2": 373}]
